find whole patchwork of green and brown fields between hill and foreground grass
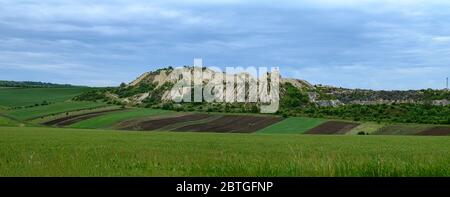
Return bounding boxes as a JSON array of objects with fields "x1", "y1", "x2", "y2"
[{"x1": 0, "y1": 87, "x2": 450, "y2": 136}]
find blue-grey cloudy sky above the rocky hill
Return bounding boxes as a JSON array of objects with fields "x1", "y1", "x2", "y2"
[{"x1": 0, "y1": 0, "x2": 450, "y2": 90}]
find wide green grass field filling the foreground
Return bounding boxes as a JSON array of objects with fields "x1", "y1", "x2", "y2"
[{"x1": 0, "y1": 127, "x2": 450, "y2": 176}]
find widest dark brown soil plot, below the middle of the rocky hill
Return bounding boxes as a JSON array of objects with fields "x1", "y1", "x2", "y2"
[{"x1": 175, "y1": 115, "x2": 282, "y2": 133}]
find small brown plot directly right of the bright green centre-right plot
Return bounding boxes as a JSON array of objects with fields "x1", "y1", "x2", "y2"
[{"x1": 306, "y1": 121, "x2": 359, "y2": 134}]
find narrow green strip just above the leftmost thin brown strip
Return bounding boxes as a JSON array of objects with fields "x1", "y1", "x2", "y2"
[{"x1": 4, "y1": 101, "x2": 107, "y2": 120}]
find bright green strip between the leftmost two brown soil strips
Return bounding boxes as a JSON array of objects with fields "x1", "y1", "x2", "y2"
[{"x1": 70, "y1": 108, "x2": 173, "y2": 129}]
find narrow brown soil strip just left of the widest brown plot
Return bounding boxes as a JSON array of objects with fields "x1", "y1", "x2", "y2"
[{"x1": 120, "y1": 114, "x2": 211, "y2": 131}]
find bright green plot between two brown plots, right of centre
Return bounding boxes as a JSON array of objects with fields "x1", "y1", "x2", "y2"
[{"x1": 258, "y1": 117, "x2": 325, "y2": 134}]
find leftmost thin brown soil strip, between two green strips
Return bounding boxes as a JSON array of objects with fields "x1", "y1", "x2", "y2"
[{"x1": 42, "y1": 109, "x2": 125, "y2": 126}]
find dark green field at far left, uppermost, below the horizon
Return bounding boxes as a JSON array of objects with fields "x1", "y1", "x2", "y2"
[{"x1": 0, "y1": 87, "x2": 90, "y2": 107}]
